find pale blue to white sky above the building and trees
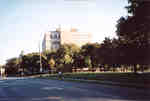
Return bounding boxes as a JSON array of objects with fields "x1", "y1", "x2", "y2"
[{"x1": 0, "y1": 0, "x2": 127, "y2": 64}]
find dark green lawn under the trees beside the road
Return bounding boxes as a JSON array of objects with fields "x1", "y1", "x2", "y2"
[{"x1": 39, "y1": 72, "x2": 150, "y2": 85}]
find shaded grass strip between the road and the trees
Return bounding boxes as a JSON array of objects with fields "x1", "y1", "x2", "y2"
[{"x1": 36, "y1": 72, "x2": 150, "y2": 87}]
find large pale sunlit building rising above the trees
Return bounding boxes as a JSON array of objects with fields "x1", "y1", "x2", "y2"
[{"x1": 42, "y1": 28, "x2": 92, "y2": 51}]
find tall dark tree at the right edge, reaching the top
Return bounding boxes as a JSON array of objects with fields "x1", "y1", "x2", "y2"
[{"x1": 116, "y1": 0, "x2": 150, "y2": 73}]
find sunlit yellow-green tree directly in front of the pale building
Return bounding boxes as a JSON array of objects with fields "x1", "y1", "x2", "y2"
[{"x1": 56, "y1": 44, "x2": 79, "y2": 72}]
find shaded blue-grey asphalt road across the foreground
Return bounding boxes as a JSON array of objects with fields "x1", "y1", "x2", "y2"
[{"x1": 0, "y1": 78, "x2": 150, "y2": 101}]
